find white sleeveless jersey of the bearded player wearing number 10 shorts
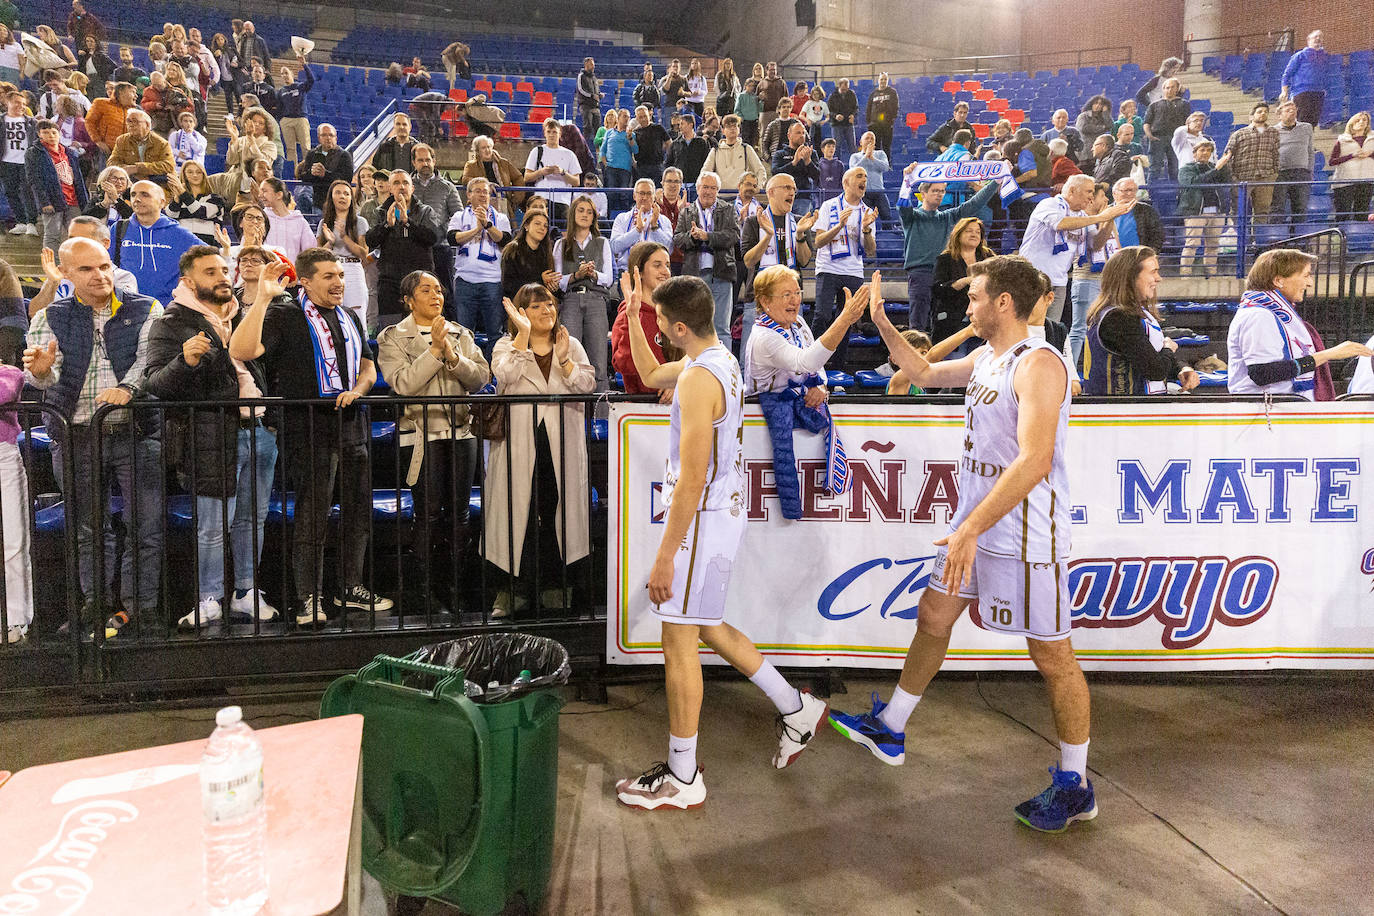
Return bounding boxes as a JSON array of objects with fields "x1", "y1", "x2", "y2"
[{"x1": 949, "y1": 338, "x2": 1072, "y2": 563}]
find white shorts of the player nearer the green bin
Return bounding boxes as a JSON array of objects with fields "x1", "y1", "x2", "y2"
[{"x1": 654, "y1": 508, "x2": 747, "y2": 626}]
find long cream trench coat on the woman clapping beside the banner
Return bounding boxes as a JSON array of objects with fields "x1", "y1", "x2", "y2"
[{"x1": 482, "y1": 335, "x2": 596, "y2": 575}]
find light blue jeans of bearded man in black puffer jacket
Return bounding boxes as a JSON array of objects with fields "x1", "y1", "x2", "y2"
[{"x1": 195, "y1": 426, "x2": 276, "y2": 597}]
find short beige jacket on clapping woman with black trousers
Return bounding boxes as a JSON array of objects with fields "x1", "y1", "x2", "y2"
[{"x1": 376, "y1": 314, "x2": 492, "y2": 486}]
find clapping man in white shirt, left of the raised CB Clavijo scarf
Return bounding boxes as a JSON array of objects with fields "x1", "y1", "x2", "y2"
[{"x1": 812, "y1": 166, "x2": 878, "y2": 368}]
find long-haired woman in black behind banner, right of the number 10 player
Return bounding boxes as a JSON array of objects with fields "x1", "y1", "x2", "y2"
[{"x1": 1083, "y1": 244, "x2": 1198, "y2": 396}]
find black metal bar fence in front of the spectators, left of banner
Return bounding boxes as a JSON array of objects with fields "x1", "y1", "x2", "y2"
[{"x1": 0, "y1": 396, "x2": 623, "y2": 691}]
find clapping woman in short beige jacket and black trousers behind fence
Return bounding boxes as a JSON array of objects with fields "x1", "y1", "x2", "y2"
[{"x1": 376, "y1": 271, "x2": 492, "y2": 607}]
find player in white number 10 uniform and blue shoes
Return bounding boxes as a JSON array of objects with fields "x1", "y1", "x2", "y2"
[{"x1": 830, "y1": 255, "x2": 1098, "y2": 832}]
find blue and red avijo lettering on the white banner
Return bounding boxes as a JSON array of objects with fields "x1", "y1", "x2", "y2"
[{"x1": 1069, "y1": 556, "x2": 1279, "y2": 648}]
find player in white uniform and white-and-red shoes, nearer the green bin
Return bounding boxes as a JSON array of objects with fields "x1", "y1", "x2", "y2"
[{"x1": 616, "y1": 266, "x2": 826, "y2": 809}]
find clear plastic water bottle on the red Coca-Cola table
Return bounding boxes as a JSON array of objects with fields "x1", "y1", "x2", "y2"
[{"x1": 201, "y1": 706, "x2": 267, "y2": 916}]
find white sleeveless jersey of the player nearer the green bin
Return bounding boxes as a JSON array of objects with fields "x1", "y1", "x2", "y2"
[{"x1": 662, "y1": 343, "x2": 745, "y2": 511}]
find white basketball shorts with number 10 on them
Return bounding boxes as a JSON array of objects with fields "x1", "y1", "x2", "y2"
[{"x1": 929, "y1": 547, "x2": 1072, "y2": 641}]
